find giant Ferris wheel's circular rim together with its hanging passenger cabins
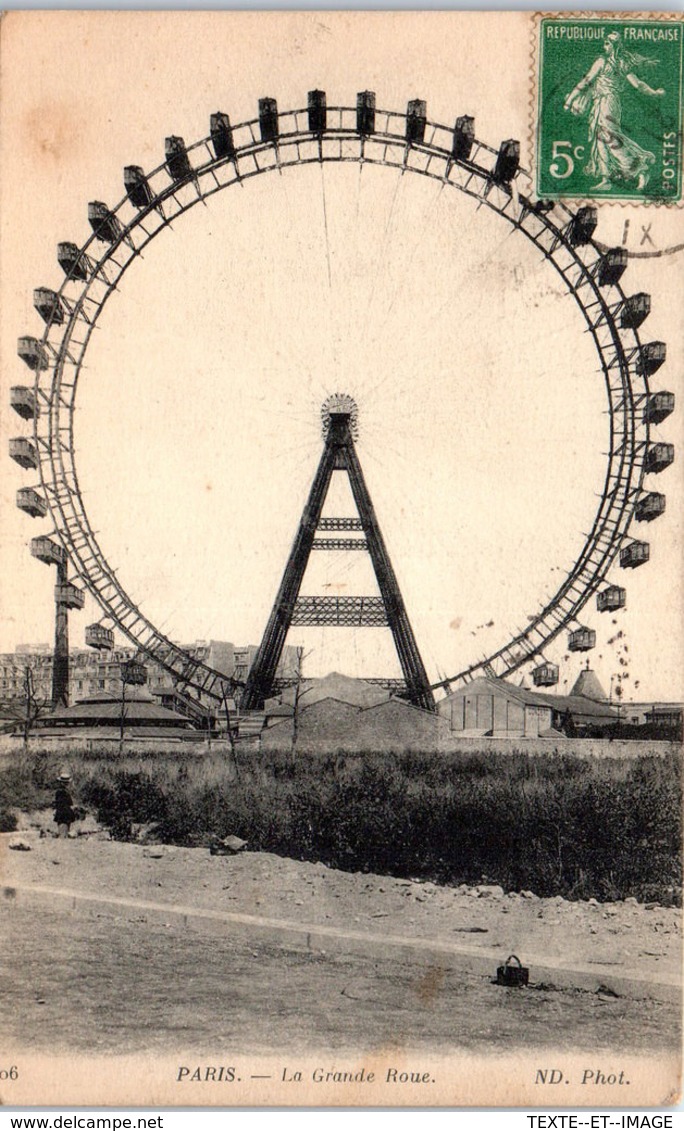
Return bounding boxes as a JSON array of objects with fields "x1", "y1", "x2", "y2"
[{"x1": 10, "y1": 90, "x2": 674, "y2": 699}]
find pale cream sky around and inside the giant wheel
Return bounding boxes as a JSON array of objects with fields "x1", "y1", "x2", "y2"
[{"x1": 0, "y1": 12, "x2": 684, "y2": 699}]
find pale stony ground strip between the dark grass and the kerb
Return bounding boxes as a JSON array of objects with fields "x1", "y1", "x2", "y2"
[{"x1": 0, "y1": 812, "x2": 682, "y2": 978}]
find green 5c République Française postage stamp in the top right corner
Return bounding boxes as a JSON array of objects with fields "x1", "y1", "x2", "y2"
[{"x1": 536, "y1": 17, "x2": 684, "y2": 204}]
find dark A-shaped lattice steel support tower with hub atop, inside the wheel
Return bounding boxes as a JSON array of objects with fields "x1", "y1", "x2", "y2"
[{"x1": 241, "y1": 395, "x2": 434, "y2": 710}]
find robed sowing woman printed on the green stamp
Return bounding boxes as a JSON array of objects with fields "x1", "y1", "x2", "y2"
[{"x1": 563, "y1": 32, "x2": 665, "y2": 192}]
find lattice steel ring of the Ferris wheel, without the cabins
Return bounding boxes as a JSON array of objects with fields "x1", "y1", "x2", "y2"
[{"x1": 18, "y1": 99, "x2": 649, "y2": 694}]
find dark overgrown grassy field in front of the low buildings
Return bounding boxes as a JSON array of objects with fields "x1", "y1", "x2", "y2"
[{"x1": 0, "y1": 751, "x2": 682, "y2": 904}]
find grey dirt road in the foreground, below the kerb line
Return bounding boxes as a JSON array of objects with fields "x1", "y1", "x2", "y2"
[{"x1": 0, "y1": 907, "x2": 678, "y2": 1055}]
